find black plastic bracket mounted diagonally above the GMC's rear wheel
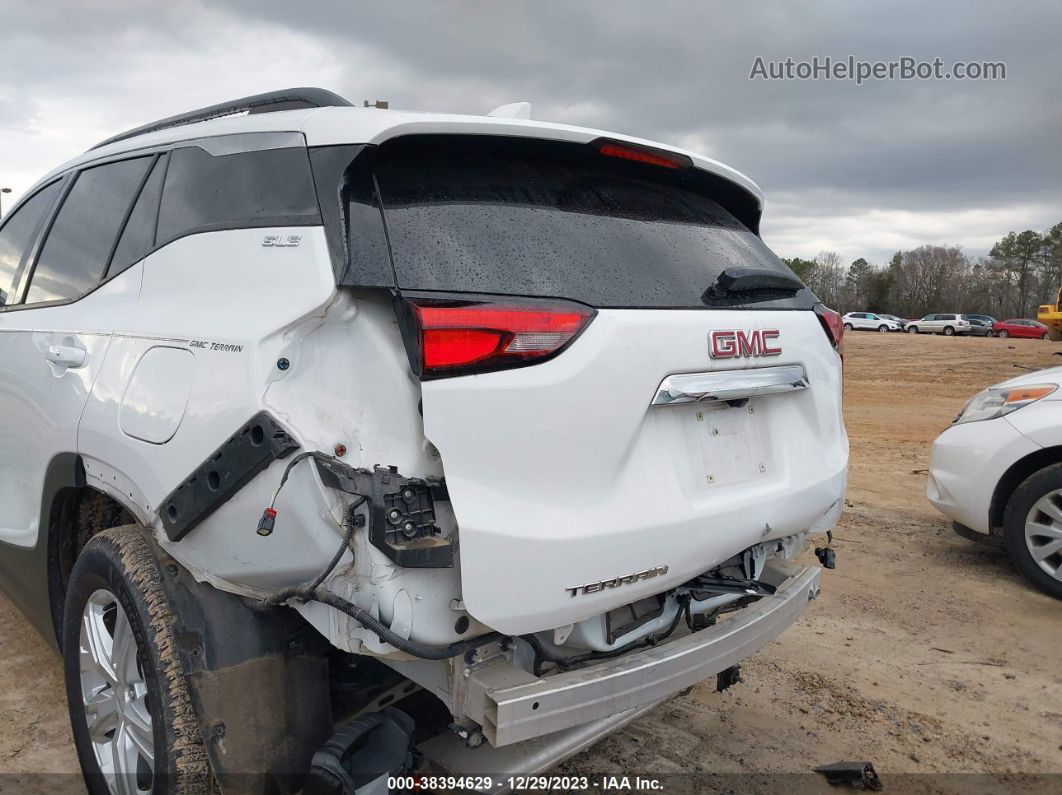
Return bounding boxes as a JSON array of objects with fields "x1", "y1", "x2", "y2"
[{"x1": 158, "y1": 412, "x2": 298, "y2": 541}]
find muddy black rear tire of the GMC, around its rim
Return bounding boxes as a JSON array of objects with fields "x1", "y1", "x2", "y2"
[{"x1": 63, "y1": 524, "x2": 211, "y2": 795}]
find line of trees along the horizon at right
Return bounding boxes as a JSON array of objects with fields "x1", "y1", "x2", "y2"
[{"x1": 785, "y1": 222, "x2": 1062, "y2": 319}]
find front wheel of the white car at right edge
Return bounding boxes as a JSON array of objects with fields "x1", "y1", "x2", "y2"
[{"x1": 1004, "y1": 464, "x2": 1062, "y2": 599}]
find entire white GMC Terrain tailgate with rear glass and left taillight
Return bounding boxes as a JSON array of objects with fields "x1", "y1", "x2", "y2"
[{"x1": 375, "y1": 139, "x2": 847, "y2": 633}]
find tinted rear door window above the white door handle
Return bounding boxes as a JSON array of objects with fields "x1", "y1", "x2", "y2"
[{"x1": 25, "y1": 157, "x2": 154, "y2": 304}]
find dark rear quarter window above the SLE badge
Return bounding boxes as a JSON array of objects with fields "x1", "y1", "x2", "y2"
[{"x1": 156, "y1": 146, "x2": 321, "y2": 245}]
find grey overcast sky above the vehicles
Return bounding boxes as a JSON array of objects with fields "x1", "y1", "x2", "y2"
[{"x1": 0, "y1": 0, "x2": 1062, "y2": 263}]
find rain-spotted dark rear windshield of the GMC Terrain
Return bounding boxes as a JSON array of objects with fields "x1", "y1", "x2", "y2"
[{"x1": 375, "y1": 139, "x2": 813, "y2": 308}]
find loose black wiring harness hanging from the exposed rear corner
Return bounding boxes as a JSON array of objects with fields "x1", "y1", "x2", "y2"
[{"x1": 258, "y1": 452, "x2": 502, "y2": 660}]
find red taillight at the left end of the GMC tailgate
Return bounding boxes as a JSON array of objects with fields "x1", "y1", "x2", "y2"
[{"x1": 399, "y1": 297, "x2": 595, "y2": 380}]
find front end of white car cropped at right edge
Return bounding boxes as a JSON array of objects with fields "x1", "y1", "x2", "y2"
[{"x1": 926, "y1": 367, "x2": 1062, "y2": 599}]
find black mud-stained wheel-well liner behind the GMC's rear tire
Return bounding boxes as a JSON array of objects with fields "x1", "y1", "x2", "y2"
[{"x1": 153, "y1": 545, "x2": 332, "y2": 795}]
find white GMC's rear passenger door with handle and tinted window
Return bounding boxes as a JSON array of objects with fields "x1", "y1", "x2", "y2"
[{"x1": 0, "y1": 156, "x2": 154, "y2": 546}]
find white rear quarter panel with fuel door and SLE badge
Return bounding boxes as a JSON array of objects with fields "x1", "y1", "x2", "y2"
[{"x1": 78, "y1": 227, "x2": 336, "y2": 587}]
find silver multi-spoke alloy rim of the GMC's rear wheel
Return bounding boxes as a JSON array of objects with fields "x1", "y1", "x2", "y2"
[{"x1": 80, "y1": 589, "x2": 155, "y2": 795}]
